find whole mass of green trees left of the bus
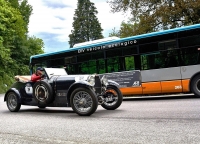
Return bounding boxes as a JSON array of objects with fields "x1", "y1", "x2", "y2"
[{"x1": 0, "y1": 0, "x2": 44, "y2": 93}]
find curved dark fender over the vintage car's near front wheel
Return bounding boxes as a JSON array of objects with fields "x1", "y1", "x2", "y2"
[{"x1": 67, "y1": 81, "x2": 94, "y2": 106}]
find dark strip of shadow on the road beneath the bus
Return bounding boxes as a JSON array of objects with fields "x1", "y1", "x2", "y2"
[{"x1": 123, "y1": 94, "x2": 199, "y2": 101}]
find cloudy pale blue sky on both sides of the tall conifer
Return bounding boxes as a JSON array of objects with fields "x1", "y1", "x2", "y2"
[{"x1": 28, "y1": 0, "x2": 128, "y2": 53}]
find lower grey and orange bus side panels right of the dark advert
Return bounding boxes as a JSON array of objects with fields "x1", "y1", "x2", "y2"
[{"x1": 142, "y1": 67, "x2": 182, "y2": 94}]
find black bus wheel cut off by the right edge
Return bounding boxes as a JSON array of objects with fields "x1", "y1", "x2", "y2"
[{"x1": 190, "y1": 75, "x2": 200, "y2": 98}]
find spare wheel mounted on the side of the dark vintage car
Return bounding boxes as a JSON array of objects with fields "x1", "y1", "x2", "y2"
[{"x1": 33, "y1": 81, "x2": 53, "y2": 107}]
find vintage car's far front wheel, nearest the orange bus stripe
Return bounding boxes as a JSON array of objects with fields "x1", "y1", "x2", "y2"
[{"x1": 101, "y1": 86, "x2": 123, "y2": 110}]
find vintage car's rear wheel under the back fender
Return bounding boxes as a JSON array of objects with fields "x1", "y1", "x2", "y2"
[{"x1": 6, "y1": 92, "x2": 21, "y2": 112}]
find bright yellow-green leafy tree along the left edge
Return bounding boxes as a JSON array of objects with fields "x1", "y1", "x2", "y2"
[{"x1": 0, "y1": 0, "x2": 25, "y2": 93}]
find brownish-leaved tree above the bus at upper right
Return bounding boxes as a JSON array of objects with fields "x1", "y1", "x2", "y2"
[{"x1": 108, "y1": 0, "x2": 200, "y2": 33}]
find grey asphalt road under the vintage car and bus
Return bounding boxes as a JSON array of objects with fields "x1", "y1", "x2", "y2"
[{"x1": 0, "y1": 95, "x2": 200, "y2": 144}]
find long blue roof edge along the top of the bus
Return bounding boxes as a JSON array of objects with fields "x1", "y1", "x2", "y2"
[{"x1": 30, "y1": 24, "x2": 200, "y2": 62}]
